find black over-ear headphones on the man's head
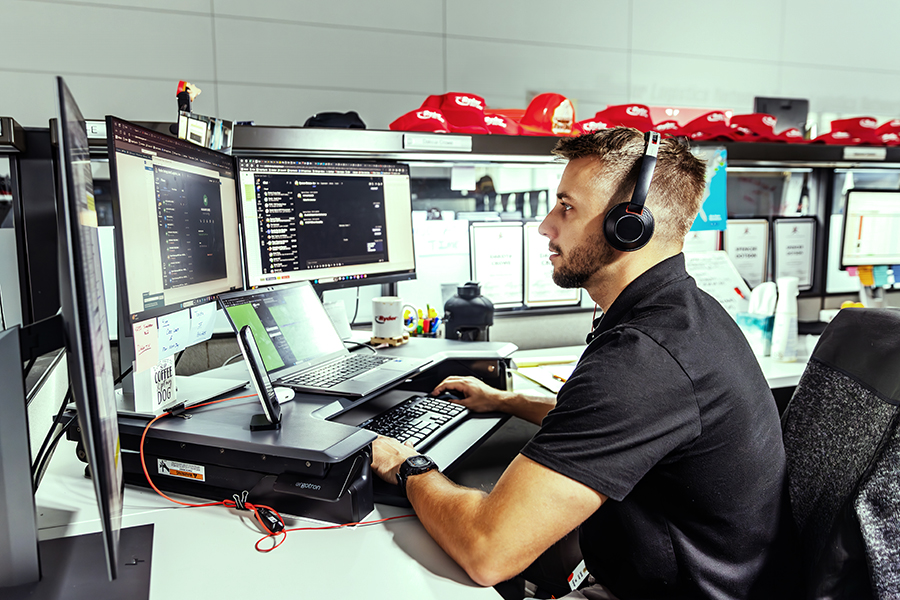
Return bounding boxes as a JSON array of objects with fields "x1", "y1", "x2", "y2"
[{"x1": 603, "y1": 131, "x2": 660, "y2": 252}]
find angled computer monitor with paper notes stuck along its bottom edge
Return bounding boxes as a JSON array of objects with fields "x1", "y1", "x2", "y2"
[{"x1": 107, "y1": 117, "x2": 243, "y2": 332}]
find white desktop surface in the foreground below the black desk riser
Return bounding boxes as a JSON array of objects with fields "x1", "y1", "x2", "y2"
[{"x1": 35, "y1": 441, "x2": 498, "y2": 600}]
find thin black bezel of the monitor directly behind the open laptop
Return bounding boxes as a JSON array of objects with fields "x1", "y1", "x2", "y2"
[{"x1": 235, "y1": 154, "x2": 416, "y2": 296}]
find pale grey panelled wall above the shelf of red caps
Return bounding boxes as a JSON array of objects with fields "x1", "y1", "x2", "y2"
[{"x1": 0, "y1": 0, "x2": 900, "y2": 129}]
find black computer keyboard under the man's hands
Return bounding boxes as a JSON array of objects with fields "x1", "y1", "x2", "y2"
[{"x1": 359, "y1": 396, "x2": 469, "y2": 450}]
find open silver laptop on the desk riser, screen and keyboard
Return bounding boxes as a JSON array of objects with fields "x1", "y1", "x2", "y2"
[{"x1": 219, "y1": 281, "x2": 431, "y2": 398}]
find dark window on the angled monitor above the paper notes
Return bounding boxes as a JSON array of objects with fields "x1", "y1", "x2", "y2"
[{"x1": 153, "y1": 166, "x2": 228, "y2": 289}]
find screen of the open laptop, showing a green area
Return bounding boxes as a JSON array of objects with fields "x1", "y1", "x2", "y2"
[{"x1": 220, "y1": 281, "x2": 347, "y2": 373}]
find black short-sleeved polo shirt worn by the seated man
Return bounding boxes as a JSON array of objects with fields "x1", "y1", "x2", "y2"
[{"x1": 522, "y1": 254, "x2": 791, "y2": 600}]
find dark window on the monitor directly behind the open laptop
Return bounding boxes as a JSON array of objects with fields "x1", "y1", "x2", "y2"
[{"x1": 255, "y1": 175, "x2": 388, "y2": 273}]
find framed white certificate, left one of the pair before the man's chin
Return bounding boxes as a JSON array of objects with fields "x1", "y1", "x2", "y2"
[{"x1": 469, "y1": 222, "x2": 524, "y2": 308}]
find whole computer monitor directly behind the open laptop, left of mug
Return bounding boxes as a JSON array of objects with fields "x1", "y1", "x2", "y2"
[{"x1": 237, "y1": 157, "x2": 416, "y2": 291}]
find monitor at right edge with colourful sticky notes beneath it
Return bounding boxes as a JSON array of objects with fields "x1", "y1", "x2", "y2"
[{"x1": 841, "y1": 189, "x2": 900, "y2": 275}]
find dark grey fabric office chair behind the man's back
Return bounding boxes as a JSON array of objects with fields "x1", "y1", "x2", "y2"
[{"x1": 782, "y1": 308, "x2": 900, "y2": 600}]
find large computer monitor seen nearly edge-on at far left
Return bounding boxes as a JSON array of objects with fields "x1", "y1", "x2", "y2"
[{"x1": 57, "y1": 77, "x2": 124, "y2": 579}]
